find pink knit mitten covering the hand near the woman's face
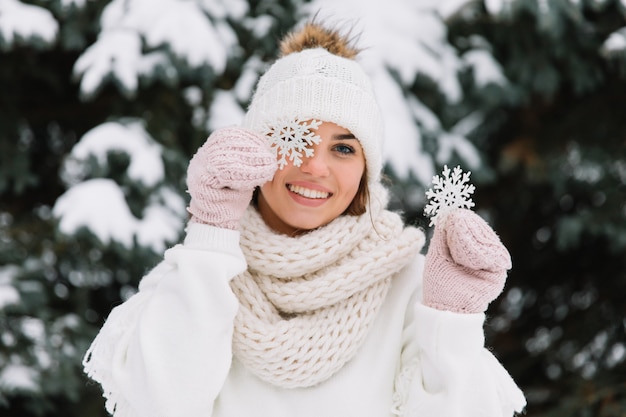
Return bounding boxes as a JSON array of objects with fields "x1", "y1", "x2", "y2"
[{"x1": 187, "y1": 127, "x2": 277, "y2": 230}]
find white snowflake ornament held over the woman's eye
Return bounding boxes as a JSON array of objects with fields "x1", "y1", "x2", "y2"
[{"x1": 265, "y1": 118, "x2": 322, "y2": 169}]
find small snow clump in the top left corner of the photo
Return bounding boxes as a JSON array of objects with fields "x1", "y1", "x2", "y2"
[{"x1": 0, "y1": 0, "x2": 59, "y2": 45}]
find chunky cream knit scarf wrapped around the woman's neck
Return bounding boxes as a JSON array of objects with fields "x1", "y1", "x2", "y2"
[{"x1": 231, "y1": 185, "x2": 424, "y2": 388}]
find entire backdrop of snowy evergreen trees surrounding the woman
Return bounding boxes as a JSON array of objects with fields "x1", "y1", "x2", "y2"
[{"x1": 0, "y1": 0, "x2": 626, "y2": 416}]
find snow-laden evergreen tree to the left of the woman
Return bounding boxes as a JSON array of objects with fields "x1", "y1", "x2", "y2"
[{"x1": 0, "y1": 0, "x2": 300, "y2": 416}]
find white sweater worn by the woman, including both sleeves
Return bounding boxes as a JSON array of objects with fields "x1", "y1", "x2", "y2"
[{"x1": 85, "y1": 224, "x2": 525, "y2": 417}]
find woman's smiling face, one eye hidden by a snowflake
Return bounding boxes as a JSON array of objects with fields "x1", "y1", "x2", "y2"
[{"x1": 258, "y1": 122, "x2": 365, "y2": 235}]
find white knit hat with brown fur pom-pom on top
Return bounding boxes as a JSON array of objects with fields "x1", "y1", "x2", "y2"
[{"x1": 244, "y1": 23, "x2": 383, "y2": 183}]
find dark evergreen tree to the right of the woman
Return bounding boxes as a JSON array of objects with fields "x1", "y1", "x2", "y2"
[{"x1": 447, "y1": 0, "x2": 626, "y2": 416}]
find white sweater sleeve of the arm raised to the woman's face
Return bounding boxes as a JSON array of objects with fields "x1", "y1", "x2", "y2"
[{"x1": 83, "y1": 223, "x2": 246, "y2": 417}]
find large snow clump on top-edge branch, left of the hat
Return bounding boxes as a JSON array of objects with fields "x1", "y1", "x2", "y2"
[{"x1": 74, "y1": 0, "x2": 248, "y2": 97}]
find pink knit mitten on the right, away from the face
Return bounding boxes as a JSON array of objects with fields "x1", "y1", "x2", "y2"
[{"x1": 424, "y1": 209, "x2": 511, "y2": 313}]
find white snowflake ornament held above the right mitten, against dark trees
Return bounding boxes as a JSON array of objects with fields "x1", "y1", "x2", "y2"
[{"x1": 424, "y1": 165, "x2": 476, "y2": 226}]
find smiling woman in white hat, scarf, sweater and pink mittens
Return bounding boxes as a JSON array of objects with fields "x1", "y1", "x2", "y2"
[{"x1": 85, "y1": 24, "x2": 525, "y2": 417}]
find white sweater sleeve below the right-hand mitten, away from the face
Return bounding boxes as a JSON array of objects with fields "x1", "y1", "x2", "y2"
[{"x1": 395, "y1": 270, "x2": 526, "y2": 417}]
